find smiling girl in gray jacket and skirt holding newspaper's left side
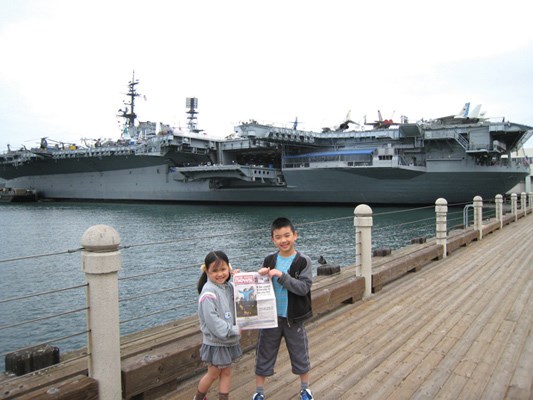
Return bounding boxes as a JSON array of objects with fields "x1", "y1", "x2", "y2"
[{"x1": 194, "y1": 251, "x2": 242, "y2": 400}]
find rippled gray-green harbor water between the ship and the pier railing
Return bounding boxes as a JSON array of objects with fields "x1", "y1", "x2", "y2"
[{"x1": 0, "y1": 202, "x2": 442, "y2": 368}]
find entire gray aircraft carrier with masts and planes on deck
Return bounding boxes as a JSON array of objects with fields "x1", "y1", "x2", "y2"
[{"x1": 0, "y1": 79, "x2": 533, "y2": 205}]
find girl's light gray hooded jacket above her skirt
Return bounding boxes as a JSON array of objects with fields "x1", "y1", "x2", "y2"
[{"x1": 198, "y1": 279, "x2": 240, "y2": 346}]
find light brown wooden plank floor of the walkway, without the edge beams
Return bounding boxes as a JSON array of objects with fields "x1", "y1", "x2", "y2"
[{"x1": 161, "y1": 214, "x2": 533, "y2": 400}]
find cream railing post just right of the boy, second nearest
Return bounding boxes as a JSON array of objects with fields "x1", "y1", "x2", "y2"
[{"x1": 354, "y1": 204, "x2": 372, "y2": 297}]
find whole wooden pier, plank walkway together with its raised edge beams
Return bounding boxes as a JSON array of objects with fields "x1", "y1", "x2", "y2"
[{"x1": 0, "y1": 210, "x2": 533, "y2": 400}]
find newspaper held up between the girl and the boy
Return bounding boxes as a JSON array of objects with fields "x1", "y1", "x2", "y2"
[{"x1": 233, "y1": 272, "x2": 278, "y2": 329}]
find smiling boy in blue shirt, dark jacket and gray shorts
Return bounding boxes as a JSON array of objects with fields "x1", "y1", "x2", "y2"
[{"x1": 252, "y1": 218, "x2": 313, "y2": 400}]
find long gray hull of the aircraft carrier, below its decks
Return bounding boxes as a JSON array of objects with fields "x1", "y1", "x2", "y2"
[{"x1": 5, "y1": 165, "x2": 527, "y2": 204}]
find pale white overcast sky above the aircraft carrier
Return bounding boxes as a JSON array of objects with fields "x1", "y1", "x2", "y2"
[{"x1": 0, "y1": 0, "x2": 533, "y2": 151}]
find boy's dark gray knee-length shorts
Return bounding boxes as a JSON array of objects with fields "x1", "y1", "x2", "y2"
[{"x1": 255, "y1": 317, "x2": 311, "y2": 376}]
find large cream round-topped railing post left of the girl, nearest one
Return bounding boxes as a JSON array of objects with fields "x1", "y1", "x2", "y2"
[{"x1": 81, "y1": 225, "x2": 122, "y2": 400}]
